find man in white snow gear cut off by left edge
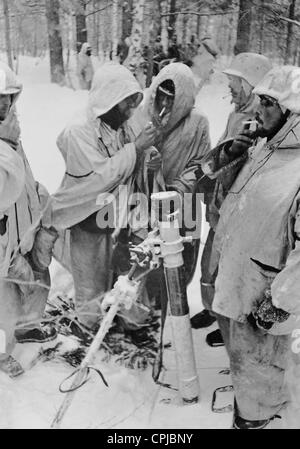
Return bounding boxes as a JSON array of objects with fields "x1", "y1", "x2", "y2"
[{"x1": 0, "y1": 63, "x2": 56, "y2": 377}]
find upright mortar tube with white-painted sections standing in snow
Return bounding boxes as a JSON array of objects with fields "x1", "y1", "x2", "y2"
[{"x1": 151, "y1": 192, "x2": 199, "y2": 404}]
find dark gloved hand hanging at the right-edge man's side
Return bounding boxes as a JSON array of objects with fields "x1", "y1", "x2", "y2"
[{"x1": 247, "y1": 290, "x2": 290, "y2": 331}]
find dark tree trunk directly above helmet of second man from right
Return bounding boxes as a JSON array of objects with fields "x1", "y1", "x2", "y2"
[{"x1": 234, "y1": 0, "x2": 252, "y2": 54}]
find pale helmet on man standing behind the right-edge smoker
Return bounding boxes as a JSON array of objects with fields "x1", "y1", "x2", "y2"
[{"x1": 223, "y1": 53, "x2": 272, "y2": 87}]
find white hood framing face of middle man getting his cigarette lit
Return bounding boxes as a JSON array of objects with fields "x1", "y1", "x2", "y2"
[{"x1": 145, "y1": 62, "x2": 196, "y2": 131}]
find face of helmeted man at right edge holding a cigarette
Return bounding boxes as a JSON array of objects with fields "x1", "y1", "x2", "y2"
[{"x1": 256, "y1": 95, "x2": 284, "y2": 137}]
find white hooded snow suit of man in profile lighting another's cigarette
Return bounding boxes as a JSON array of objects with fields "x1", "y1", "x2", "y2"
[{"x1": 52, "y1": 63, "x2": 143, "y2": 327}]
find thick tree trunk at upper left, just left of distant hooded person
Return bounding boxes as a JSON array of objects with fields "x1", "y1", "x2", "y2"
[{"x1": 46, "y1": 0, "x2": 65, "y2": 84}]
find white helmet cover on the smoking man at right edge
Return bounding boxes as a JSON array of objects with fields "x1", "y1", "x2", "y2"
[{"x1": 253, "y1": 65, "x2": 300, "y2": 114}]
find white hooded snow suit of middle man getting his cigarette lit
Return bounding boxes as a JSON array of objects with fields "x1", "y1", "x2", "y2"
[{"x1": 132, "y1": 63, "x2": 210, "y2": 308}]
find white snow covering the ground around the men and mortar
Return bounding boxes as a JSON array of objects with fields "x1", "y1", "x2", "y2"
[{"x1": 0, "y1": 57, "x2": 298, "y2": 429}]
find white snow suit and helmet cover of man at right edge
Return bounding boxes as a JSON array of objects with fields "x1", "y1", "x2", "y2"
[{"x1": 206, "y1": 66, "x2": 300, "y2": 420}]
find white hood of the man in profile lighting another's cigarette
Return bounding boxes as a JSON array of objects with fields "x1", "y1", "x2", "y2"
[{"x1": 88, "y1": 62, "x2": 143, "y2": 119}]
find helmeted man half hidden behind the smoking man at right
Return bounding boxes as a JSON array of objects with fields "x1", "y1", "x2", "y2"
[{"x1": 192, "y1": 53, "x2": 271, "y2": 346}]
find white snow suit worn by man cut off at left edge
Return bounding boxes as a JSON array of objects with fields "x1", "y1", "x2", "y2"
[{"x1": 0, "y1": 63, "x2": 50, "y2": 357}]
